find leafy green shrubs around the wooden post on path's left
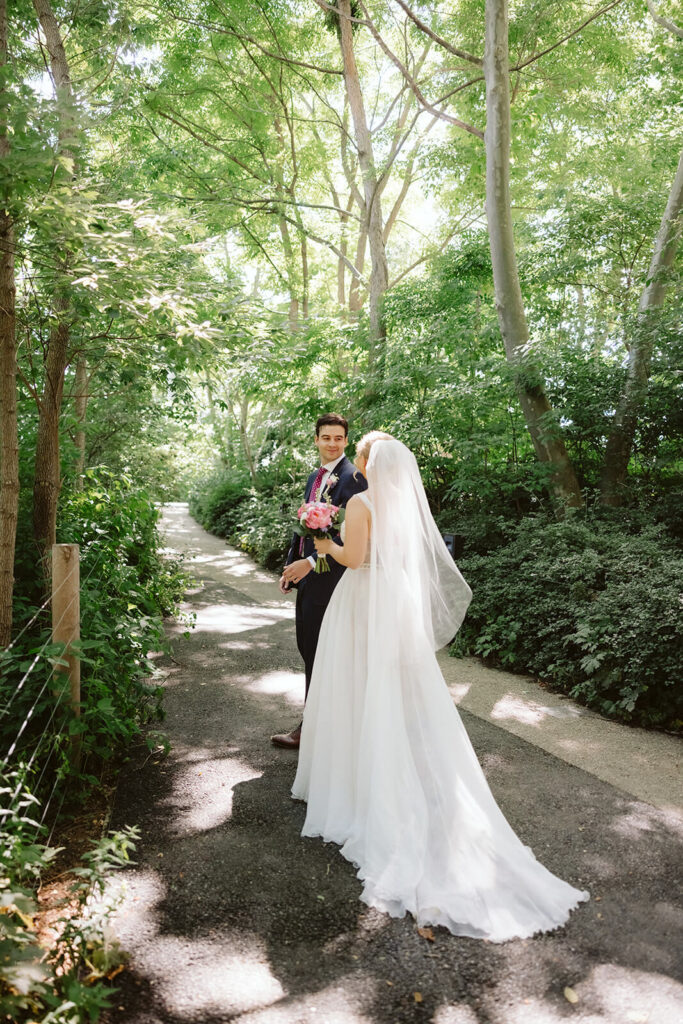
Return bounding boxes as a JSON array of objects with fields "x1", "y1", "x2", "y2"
[{"x1": 0, "y1": 470, "x2": 186, "y2": 792}]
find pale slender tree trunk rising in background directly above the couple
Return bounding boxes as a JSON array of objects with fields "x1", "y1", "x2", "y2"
[{"x1": 339, "y1": 0, "x2": 389, "y2": 372}]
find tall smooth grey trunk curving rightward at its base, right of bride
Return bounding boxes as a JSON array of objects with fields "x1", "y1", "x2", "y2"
[{"x1": 483, "y1": 0, "x2": 582, "y2": 506}]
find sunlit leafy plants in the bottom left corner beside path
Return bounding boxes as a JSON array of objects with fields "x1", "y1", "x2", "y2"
[{"x1": 0, "y1": 768, "x2": 138, "y2": 1024}]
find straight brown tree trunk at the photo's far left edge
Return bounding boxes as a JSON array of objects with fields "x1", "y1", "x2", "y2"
[{"x1": 0, "y1": 0, "x2": 19, "y2": 647}]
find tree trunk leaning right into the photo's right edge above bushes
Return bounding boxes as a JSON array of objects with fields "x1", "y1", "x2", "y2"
[{"x1": 600, "y1": 146, "x2": 683, "y2": 505}]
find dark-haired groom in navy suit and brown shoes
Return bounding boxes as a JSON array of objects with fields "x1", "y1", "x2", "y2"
[{"x1": 270, "y1": 413, "x2": 368, "y2": 750}]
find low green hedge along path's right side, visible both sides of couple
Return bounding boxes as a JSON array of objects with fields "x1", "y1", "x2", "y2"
[{"x1": 190, "y1": 475, "x2": 683, "y2": 729}]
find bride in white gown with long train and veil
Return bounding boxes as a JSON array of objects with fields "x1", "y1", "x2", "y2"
[{"x1": 292, "y1": 431, "x2": 589, "y2": 942}]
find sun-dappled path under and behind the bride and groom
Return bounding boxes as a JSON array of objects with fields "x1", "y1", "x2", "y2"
[{"x1": 104, "y1": 506, "x2": 683, "y2": 1024}]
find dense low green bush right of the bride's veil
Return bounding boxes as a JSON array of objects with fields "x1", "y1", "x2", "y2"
[{"x1": 453, "y1": 514, "x2": 683, "y2": 728}]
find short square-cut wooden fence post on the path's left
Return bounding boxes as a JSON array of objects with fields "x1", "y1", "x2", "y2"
[{"x1": 52, "y1": 544, "x2": 81, "y2": 767}]
